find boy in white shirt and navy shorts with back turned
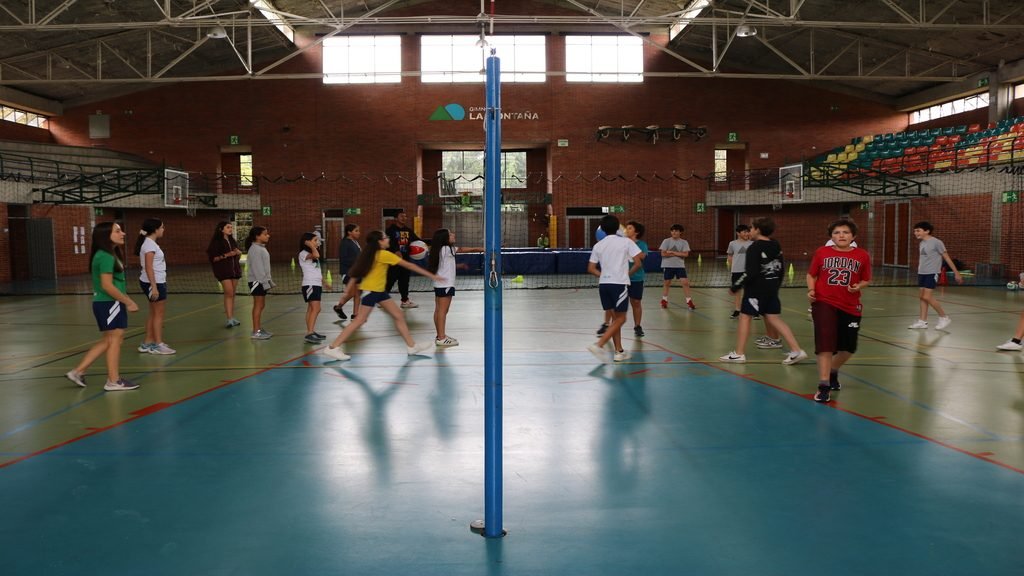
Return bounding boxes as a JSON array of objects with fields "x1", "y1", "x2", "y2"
[{"x1": 587, "y1": 214, "x2": 643, "y2": 363}]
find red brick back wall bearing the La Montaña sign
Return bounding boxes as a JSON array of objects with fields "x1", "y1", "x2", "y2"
[{"x1": 29, "y1": 31, "x2": 906, "y2": 270}]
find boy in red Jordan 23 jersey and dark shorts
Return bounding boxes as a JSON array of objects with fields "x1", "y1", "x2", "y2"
[{"x1": 807, "y1": 218, "x2": 871, "y2": 402}]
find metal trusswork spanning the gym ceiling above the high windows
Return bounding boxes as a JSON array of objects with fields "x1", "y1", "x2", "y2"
[{"x1": 0, "y1": 0, "x2": 1024, "y2": 91}]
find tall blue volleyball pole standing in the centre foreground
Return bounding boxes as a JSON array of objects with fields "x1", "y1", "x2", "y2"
[{"x1": 483, "y1": 48, "x2": 505, "y2": 538}]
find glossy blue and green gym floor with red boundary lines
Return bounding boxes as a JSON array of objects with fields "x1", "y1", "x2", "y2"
[{"x1": 0, "y1": 291, "x2": 1024, "y2": 576}]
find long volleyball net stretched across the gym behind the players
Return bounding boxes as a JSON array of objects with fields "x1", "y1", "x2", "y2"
[{"x1": 8, "y1": 165, "x2": 1024, "y2": 293}]
